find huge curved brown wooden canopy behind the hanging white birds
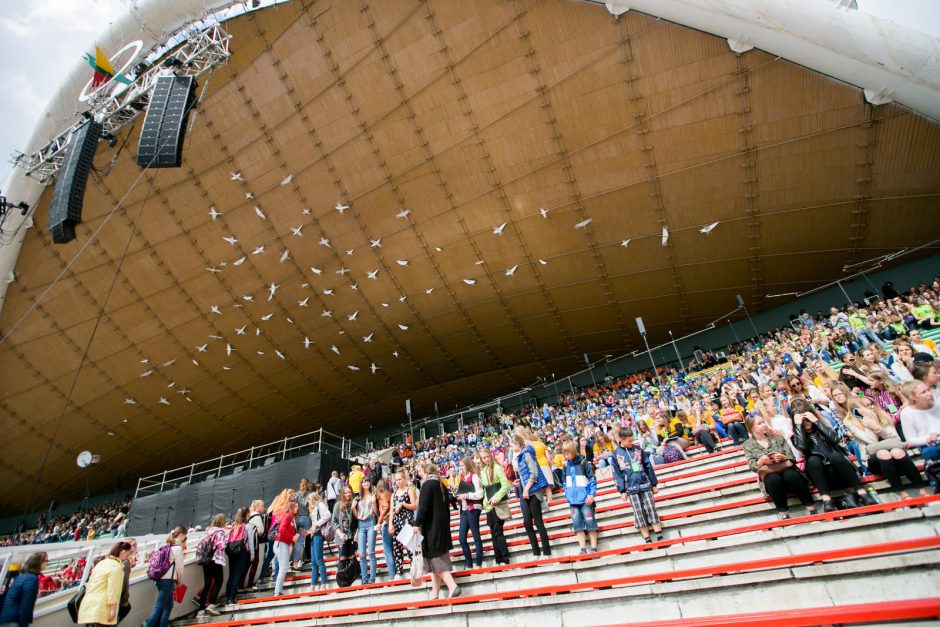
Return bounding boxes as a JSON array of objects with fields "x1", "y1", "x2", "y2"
[{"x1": 0, "y1": 0, "x2": 940, "y2": 509}]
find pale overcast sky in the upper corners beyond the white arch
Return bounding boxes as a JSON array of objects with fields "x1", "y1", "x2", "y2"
[{"x1": 0, "y1": 0, "x2": 940, "y2": 191}]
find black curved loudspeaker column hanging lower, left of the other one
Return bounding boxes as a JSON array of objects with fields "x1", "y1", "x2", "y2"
[{"x1": 49, "y1": 120, "x2": 101, "y2": 244}]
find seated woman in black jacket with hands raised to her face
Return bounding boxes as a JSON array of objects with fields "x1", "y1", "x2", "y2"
[{"x1": 790, "y1": 399, "x2": 875, "y2": 512}]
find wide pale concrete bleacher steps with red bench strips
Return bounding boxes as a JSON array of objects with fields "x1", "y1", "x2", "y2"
[{"x1": 174, "y1": 444, "x2": 940, "y2": 627}]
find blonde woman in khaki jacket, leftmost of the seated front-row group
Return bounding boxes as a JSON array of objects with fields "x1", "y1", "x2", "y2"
[{"x1": 742, "y1": 416, "x2": 816, "y2": 520}]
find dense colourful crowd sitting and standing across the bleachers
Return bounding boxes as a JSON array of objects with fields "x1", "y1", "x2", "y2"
[{"x1": 0, "y1": 277, "x2": 940, "y2": 627}]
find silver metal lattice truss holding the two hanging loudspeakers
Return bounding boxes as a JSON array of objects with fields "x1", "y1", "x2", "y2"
[{"x1": 11, "y1": 22, "x2": 231, "y2": 185}]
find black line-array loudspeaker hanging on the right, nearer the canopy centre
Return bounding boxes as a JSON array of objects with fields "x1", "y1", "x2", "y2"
[{"x1": 137, "y1": 76, "x2": 196, "y2": 168}]
